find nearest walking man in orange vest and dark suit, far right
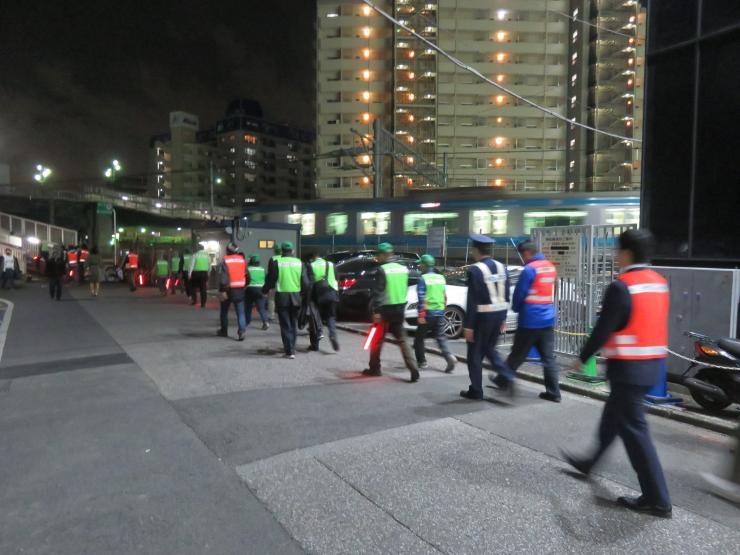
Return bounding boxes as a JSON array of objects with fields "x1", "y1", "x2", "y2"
[{"x1": 563, "y1": 229, "x2": 672, "y2": 518}]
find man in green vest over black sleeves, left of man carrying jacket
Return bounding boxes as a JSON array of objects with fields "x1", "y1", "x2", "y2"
[{"x1": 262, "y1": 241, "x2": 308, "y2": 359}]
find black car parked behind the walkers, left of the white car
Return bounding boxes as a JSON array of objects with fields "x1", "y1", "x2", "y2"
[{"x1": 335, "y1": 256, "x2": 421, "y2": 320}]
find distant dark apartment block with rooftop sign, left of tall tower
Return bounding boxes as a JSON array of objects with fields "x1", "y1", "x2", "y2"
[{"x1": 150, "y1": 99, "x2": 315, "y2": 206}]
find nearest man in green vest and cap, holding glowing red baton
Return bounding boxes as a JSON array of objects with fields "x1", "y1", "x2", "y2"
[{"x1": 362, "y1": 243, "x2": 419, "y2": 383}]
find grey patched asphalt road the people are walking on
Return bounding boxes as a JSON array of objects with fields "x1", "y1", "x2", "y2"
[{"x1": 0, "y1": 284, "x2": 740, "y2": 554}]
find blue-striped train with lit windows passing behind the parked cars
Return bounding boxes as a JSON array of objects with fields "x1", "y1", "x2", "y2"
[{"x1": 245, "y1": 189, "x2": 640, "y2": 258}]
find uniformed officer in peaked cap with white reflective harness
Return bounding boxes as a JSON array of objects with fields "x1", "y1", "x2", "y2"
[{"x1": 460, "y1": 235, "x2": 514, "y2": 401}]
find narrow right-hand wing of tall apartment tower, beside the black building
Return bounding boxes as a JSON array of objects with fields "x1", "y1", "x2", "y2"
[{"x1": 566, "y1": 0, "x2": 646, "y2": 191}]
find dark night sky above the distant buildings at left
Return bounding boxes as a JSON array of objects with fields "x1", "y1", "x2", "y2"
[{"x1": 0, "y1": 0, "x2": 315, "y2": 183}]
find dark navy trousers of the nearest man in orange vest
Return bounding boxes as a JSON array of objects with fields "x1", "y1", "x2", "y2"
[{"x1": 590, "y1": 382, "x2": 671, "y2": 507}]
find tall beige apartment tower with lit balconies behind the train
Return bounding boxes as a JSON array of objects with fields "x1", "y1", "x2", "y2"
[{"x1": 317, "y1": 0, "x2": 641, "y2": 197}]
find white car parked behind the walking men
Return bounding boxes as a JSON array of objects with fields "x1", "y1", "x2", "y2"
[{"x1": 404, "y1": 266, "x2": 522, "y2": 339}]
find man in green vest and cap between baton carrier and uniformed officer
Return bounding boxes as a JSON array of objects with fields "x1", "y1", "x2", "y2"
[{"x1": 414, "y1": 254, "x2": 457, "y2": 374}]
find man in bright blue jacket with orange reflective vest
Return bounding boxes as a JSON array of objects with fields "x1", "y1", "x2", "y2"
[{"x1": 492, "y1": 241, "x2": 561, "y2": 403}]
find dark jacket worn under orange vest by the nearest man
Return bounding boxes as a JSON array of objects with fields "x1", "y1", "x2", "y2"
[{"x1": 579, "y1": 265, "x2": 665, "y2": 385}]
